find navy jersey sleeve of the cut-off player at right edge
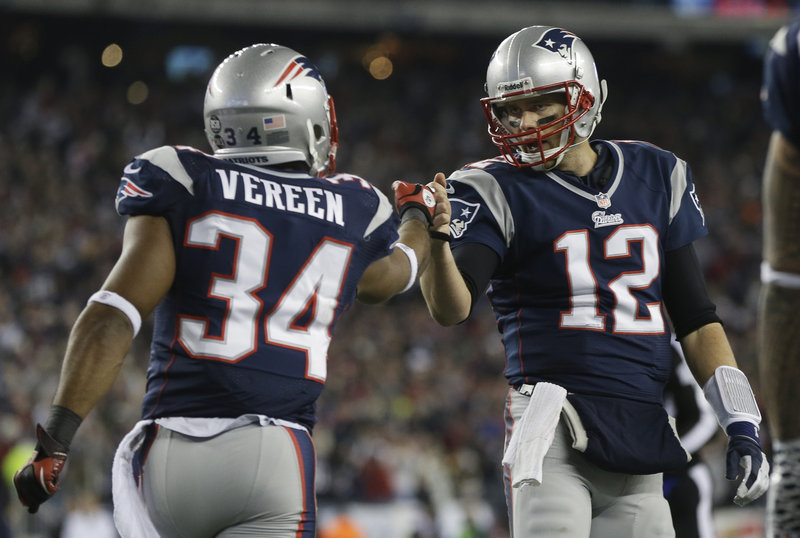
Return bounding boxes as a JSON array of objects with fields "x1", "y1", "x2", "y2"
[{"x1": 761, "y1": 21, "x2": 800, "y2": 146}]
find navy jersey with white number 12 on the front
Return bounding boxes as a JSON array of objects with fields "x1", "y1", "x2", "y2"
[{"x1": 448, "y1": 141, "x2": 706, "y2": 403}]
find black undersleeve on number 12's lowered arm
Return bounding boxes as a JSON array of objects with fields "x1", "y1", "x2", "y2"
[{"x1": 663, "y1": 244, "x2": 722, "y2": 340}]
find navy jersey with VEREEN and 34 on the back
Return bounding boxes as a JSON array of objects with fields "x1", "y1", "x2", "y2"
[{"x1": 117, "y1": 147, "x2": 398, "y2": 426}]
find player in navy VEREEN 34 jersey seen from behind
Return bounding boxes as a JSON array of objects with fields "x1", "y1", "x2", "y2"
[{"x1": 14, "y1": 44, "x2": 434, "y2": 538}]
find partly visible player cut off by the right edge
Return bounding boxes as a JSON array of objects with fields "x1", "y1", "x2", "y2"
[{"x1": 759, "y1": 21, "x2": 800, "y2": 538}]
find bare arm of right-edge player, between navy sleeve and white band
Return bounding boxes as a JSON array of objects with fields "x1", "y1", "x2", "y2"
[{"x1": 763, "y1": 132, "x2": 800, "y2": 274}]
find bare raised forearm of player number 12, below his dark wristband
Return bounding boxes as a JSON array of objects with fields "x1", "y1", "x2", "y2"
[{"x1": 420, "y1": 241, "x2": 471, "y2": 326}]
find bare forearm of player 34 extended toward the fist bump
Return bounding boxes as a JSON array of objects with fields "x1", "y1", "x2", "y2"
[{"x1": 357, "y1": 219, "x2": 430, "y2": 304}]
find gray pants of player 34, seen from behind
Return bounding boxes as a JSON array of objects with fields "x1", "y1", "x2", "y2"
[{"x1": 142, "y1": 424, "x2": 316, "y2": 538}]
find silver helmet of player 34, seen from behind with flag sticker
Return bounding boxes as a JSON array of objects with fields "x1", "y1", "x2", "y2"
[{"x1": 203, "y1": 44, "x2": 338, "y2": 176}]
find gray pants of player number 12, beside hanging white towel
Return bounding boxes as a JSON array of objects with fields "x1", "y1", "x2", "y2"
[{"x1": 504, "y1": 389, "x2": 675, "y2": 538}]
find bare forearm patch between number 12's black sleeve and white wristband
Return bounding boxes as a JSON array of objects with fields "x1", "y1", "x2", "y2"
[{"x1": 680, "y1": 323, "x2": 737, "y2": 387}]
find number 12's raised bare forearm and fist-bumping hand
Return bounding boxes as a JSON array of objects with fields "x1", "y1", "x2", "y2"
[{"x1": 420, "y1": 172, "x2": 472, "y2": 326}]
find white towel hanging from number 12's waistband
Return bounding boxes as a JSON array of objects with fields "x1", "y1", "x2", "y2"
[{"x1": 503, "y1": 383, "x2": 567, "y2": 488}]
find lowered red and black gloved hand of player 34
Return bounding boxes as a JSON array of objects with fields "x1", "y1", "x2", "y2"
[{"x1": 14, "y1": 424, "x2": 68, "y2": 514}]
